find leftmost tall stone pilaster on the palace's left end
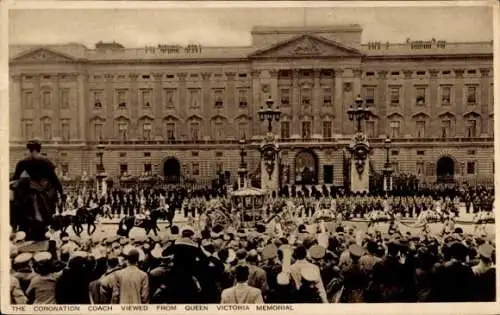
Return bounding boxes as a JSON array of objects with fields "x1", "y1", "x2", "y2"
[{"x1": 9, "y1": 75, "x2": 22, "y2": 141}]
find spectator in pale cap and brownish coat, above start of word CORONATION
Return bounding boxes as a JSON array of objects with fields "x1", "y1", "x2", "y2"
[{"x1": 26, "y1": 252, "x2": 59, "y2": 304}]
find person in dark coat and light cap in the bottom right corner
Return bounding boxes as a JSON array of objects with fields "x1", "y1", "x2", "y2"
[{"x1": 472, "y1": 243, "x2": 496, "y2": 302}]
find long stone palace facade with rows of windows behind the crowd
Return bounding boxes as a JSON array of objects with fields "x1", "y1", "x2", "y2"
[{"x1": 10, "y1": 25, "x2": 494, "y2": 185}]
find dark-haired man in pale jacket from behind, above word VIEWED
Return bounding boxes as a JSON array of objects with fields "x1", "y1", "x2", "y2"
[{"x1": 111, "y1": 249, "x2": 149, "y2": 304}]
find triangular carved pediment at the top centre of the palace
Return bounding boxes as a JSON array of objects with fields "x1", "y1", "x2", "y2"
[{"x1": 249, "y1": 34, "x2": 363, "y2": 58}]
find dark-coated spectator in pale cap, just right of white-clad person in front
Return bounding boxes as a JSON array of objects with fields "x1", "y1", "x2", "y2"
[{"x1": 341, "y1": 244, "x2": 368, "y2": 303}]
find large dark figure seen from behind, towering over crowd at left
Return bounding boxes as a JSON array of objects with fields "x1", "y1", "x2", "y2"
[{"x1": 11, "y1": 140, "x2": 64, "y2": 241}]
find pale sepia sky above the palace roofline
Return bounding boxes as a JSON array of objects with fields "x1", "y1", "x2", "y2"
[{"x1": 9, "y1": 6, "x2": 493, "y2": 47}]
